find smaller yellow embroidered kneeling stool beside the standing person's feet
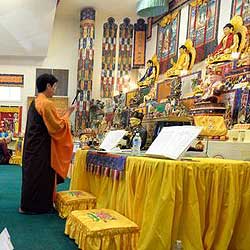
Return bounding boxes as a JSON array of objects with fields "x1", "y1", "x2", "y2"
[{"x1": 55, "y1": 190, "x2": 96, "y2": 218}]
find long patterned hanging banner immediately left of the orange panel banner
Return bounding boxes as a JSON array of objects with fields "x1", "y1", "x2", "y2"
[{"x1": 116, "y1": 18, "x2": 134, "y2": 92}]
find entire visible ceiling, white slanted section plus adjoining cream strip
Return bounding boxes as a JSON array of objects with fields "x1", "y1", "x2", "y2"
[{"x1": 0, "y1": 0, "x2": 139, "y2": 61}]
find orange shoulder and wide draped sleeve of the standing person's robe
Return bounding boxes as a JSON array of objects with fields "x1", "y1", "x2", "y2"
[{"x1": 35, "y1": 94, "x2": 73, "y2": 179}]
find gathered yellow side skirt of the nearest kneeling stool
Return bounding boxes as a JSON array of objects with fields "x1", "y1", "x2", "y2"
[{"x1": 64, "y1": 214, "x2": 139, "y2": 250}]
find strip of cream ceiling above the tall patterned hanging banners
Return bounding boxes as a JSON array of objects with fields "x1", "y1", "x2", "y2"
[{"x1": 57, "y1": 0, "x2": 137, "y2": 17}]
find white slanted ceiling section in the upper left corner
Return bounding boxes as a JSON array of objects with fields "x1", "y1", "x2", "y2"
[{"x1": 0, "y1": 0, "x2": 57, "y2": 58}]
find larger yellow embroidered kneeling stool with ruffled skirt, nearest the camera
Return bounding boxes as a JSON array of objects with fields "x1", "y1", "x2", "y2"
[{"x1": 65, "y1": 209, "x2": 139, "y2": 250}]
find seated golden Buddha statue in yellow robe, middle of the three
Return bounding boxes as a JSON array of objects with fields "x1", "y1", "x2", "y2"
[{"x1": 165, "y1": 39, "x2": 196, "y2": 78}]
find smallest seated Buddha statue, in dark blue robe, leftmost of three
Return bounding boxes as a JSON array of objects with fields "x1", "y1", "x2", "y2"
[{"x1": 137, "y1": 55, "x2": 159, "y2": 87}]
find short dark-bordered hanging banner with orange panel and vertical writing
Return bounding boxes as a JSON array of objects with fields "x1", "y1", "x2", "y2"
[{"x1": 133, "y1": 18, "x2": 147, "y2": 68}]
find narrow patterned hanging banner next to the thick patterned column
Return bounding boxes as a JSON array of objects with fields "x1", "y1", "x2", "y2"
[{"x1": 101, "y1": 17, "x2": 117, "y2": 98}]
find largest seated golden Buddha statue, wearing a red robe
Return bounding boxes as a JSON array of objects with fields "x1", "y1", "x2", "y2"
[{"x1": 207, "y1": 16, "x2": 247, "y2": 64}]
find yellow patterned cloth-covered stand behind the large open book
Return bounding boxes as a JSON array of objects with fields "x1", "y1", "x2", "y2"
[{"x1": 194, "y1": 115, "x2": 227, "y2": 136}]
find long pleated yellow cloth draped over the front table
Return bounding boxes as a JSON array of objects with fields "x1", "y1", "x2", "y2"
[{"x1": 71, "y1": 150, "x2": 250, "y2": 250}]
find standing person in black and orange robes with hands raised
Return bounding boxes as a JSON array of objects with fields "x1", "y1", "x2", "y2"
[{"x1": 19, "y1": 74, "x2": 74, "y2": 214}]
